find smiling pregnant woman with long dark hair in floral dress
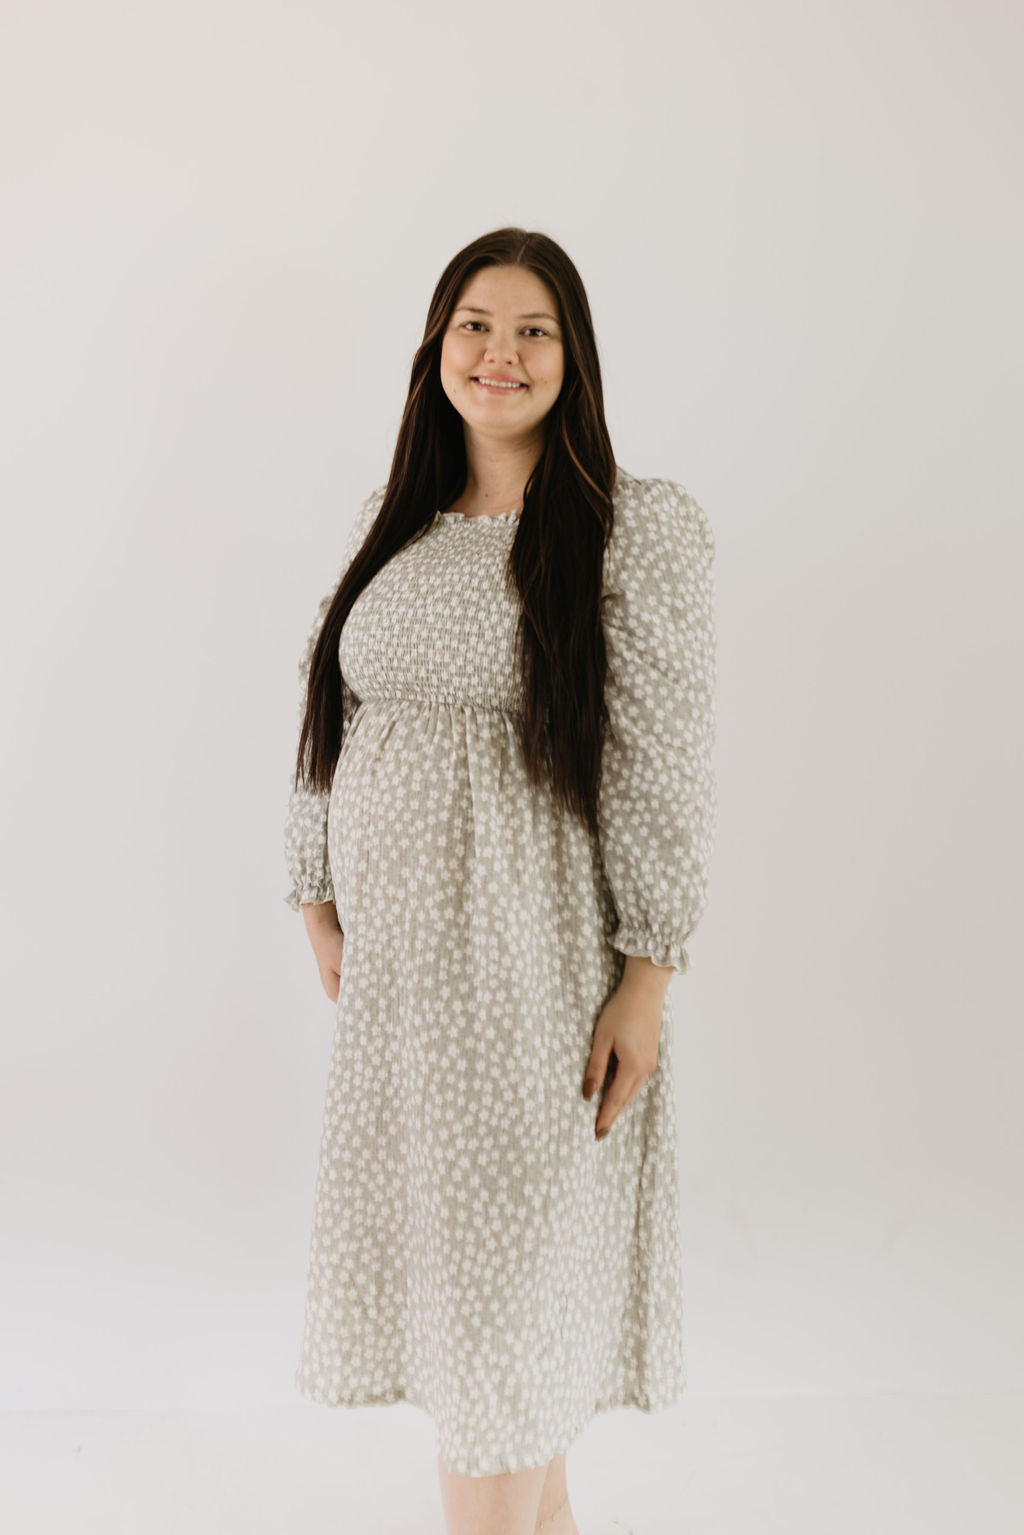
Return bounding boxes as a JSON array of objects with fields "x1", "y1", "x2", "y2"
[{"x1": 284, "y1": 229, "x2": 715, "y2": 1535}]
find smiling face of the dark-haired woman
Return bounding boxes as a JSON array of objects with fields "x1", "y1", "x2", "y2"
[{"x1": 441, "y1": 266, "x2": 565, "y2": 442}]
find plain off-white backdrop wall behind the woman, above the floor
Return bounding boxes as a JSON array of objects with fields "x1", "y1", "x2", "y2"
[{"x1": 0, "y1": 0, "x2": 1024, "y2": 1442}]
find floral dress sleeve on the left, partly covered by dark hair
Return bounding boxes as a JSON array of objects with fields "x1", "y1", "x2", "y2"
[{"x1": 284, "y1": 485, "x2": 385, "y2": 912}]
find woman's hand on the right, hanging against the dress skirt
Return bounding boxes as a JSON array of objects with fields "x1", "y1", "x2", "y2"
[{"x1": 583, "y1": 955, "x2": 672, "y2": 1141}]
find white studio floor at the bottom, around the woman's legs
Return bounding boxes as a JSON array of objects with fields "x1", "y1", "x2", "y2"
[{"x1": 0, "y1": 1394, "x2": 1024, "y2": 1535}]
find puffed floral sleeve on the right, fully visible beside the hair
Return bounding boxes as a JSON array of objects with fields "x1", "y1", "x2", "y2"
[{"x1": 597, "y1": 479, "x2": 717, "y2": 973}]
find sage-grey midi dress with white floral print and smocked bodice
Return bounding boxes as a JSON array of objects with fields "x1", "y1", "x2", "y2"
[{"x1": 284, "y1": 468, "x2": 717, "y2": 1477}]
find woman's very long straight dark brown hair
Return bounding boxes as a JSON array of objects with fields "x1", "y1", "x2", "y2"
[{"x1": 295, "y1": 229, "x2": 616, "y2": 829}]
